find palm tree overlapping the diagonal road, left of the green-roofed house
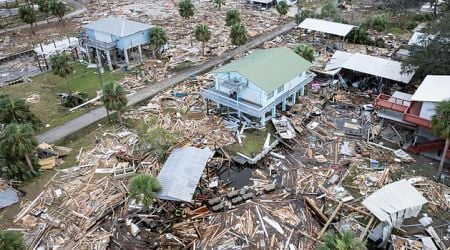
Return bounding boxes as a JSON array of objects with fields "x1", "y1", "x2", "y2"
[{"x1": 102, "y1": 82, "x2": 128, "y2": 124}]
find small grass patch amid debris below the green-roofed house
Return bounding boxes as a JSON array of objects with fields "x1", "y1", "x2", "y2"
[{"x1": 225, "y1": 122, "x2": 276, "y2": 158}]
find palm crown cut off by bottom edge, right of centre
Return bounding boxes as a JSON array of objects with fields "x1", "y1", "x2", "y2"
[{"x1": 316, "y1": 230, "x2": 366, "y2": 250}]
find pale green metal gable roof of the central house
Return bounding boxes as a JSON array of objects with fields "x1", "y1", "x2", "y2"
[{"x1": 211, "y1": 47, "x2": 312, "y2": 93}]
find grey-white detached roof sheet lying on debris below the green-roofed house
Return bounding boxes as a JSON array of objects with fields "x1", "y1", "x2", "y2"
[{"x1": 157, "y1": 147, "x2": 213, "y2": 202}]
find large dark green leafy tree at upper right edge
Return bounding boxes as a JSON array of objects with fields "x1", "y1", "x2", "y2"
[{"x1": 402, "y1": 13, "x2": 450, "y2": 79}]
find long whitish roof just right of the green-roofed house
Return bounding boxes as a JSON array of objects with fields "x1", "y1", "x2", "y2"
[{"x1": 342, "y1": 53, "x2": 414, "y2": 83}]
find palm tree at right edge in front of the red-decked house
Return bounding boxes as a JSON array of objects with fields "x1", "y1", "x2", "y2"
[{"x1": 431, "y1": 100, "x2": 450, "y2": 178}]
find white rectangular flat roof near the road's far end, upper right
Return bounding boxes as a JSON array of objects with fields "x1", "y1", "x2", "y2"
[{"x1": 298, "y1": 18, "x2": 356, "y2": 37}]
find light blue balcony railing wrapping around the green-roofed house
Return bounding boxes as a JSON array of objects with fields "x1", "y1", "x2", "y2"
[{"x1": 200, "y1": 73, "x2": 315, "y2": 117}]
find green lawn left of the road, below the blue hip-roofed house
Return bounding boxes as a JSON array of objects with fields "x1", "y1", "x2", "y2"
[{"x1": 0, "y1": 62, "x2": 124, "y2": 131}]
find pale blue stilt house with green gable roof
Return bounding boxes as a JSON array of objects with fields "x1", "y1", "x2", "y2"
[{"x1": 201, "y1": 47, "x2": 315, "y2": 125}]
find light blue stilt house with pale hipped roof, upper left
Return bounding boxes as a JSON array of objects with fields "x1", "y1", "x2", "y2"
[{"x1": 79, "y1": 17, "x2": 153, "y2": 70}]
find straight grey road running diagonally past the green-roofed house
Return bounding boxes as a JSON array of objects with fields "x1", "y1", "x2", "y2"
[{"x1": 37, "y1": 22, "x2": 297, "y2": 143}]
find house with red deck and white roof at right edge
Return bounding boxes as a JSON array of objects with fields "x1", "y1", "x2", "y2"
[{"x1": 375, "y1": 75, "x2": 450, "y2": 159}]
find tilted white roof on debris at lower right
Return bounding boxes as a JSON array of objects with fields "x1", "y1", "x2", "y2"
[{"x1": 362, "y1": 179, "x2": 428, "y2": 227}]
